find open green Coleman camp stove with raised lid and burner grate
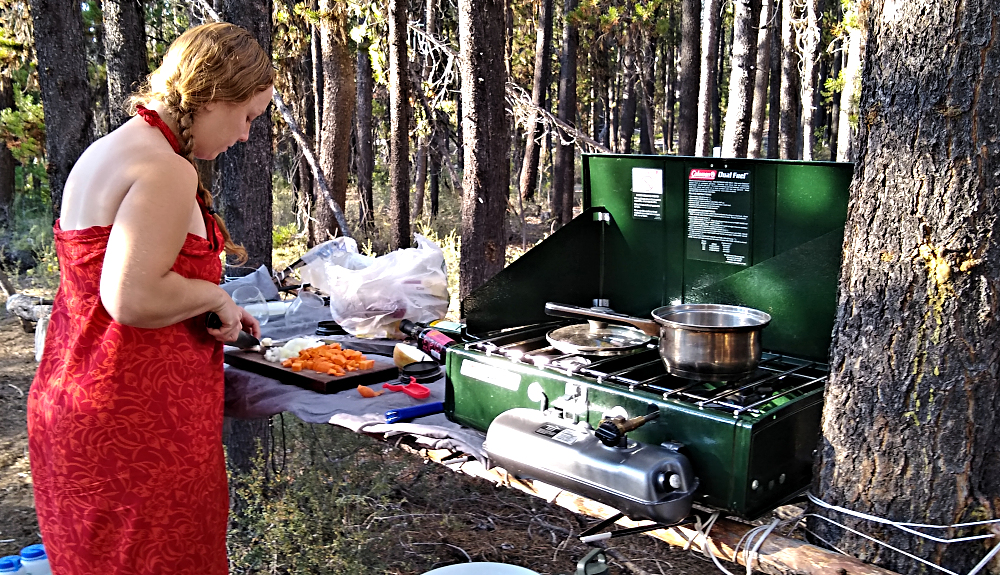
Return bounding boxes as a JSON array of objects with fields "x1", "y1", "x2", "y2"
[{"x1": 445, "y1": 155, "x2": 852, "y2": 518}]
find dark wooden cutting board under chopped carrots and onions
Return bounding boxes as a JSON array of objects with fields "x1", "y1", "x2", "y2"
[{"x1": 225, "y1": 348, "x2": 399, "y2": 393}]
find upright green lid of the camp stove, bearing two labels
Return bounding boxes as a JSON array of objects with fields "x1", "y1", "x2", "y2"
[{"x1": 584, "y1": 155, "x2": 853, "y2": 361}]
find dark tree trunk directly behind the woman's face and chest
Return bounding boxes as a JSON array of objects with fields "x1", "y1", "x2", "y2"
[{"x1": 214, "y1": 0, "x2": 273, "y2": 276}]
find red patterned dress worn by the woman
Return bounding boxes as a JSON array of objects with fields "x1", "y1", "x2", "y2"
[{"x1": 28, "y1": 208, "x2": 229, "y2": 575}]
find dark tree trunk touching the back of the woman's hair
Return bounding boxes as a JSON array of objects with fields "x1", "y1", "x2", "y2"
[{"x1": 101, "y1": 0, "x2": 149, "y2": 131}]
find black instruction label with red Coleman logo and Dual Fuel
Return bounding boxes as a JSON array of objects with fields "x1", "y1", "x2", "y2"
[{"x1": 687, "y1": 168, "x2": 753, "y2": 266}]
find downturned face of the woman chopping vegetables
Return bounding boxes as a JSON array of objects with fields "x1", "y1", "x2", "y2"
[{"x1": 191, "y1": 86, "x2": 274, "y2": 160}]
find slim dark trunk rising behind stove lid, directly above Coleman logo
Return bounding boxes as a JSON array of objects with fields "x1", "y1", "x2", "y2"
[{"x1": 677, "y1": 0, "x2": 701, "y2": 156}]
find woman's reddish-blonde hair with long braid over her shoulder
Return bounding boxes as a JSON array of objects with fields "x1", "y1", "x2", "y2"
[{"x1": 129, "y1": 22, "x2": 275, "y2": 263}]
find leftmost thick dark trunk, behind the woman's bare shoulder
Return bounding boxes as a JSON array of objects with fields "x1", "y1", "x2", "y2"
[{"x1": 30, "y1": 0, "x2": 94, "y2": 221}]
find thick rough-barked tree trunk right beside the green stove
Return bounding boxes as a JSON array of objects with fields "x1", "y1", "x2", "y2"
[{"x1": 811, "y1": 4, "x2": 1000, "y2": 573}]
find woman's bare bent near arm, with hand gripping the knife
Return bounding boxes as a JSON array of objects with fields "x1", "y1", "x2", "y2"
[{"x1": 101, "y1": 156, "x2": 259, "y2": 341}]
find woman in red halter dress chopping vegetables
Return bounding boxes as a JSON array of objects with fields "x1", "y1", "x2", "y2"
[{"x1": 28, "y1": 24, "x2": 274, "y2": 575}]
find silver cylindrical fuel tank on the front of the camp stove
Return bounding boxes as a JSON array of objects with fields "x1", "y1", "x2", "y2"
[{"x1": 483, "y1": 408, "x2": 698, "y2": 524}]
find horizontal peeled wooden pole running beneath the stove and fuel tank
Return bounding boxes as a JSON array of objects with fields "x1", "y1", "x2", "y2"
[{"x1": 427, "y1": 450, "x2": 897, "y2": 575}]
